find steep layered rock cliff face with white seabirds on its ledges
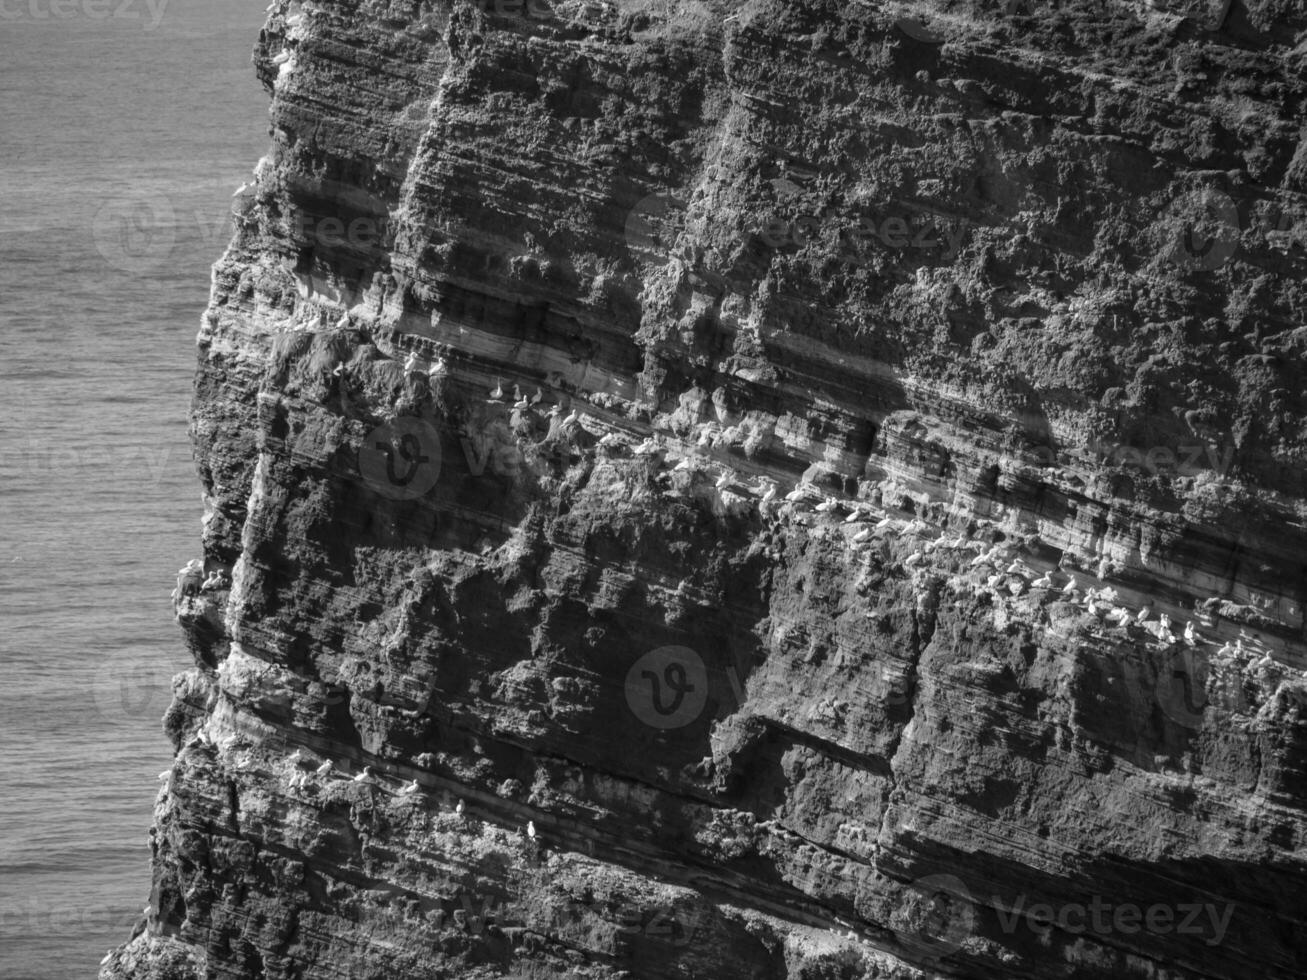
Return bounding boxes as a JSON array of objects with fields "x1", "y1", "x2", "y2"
[{"x1": 101, "y1": 0, "x2": 1307, "y2": 980}]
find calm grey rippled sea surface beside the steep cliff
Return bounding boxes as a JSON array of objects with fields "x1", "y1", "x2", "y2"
[{"x1": 0, "y1": 0, "x2": 268, "y2": 980}]
